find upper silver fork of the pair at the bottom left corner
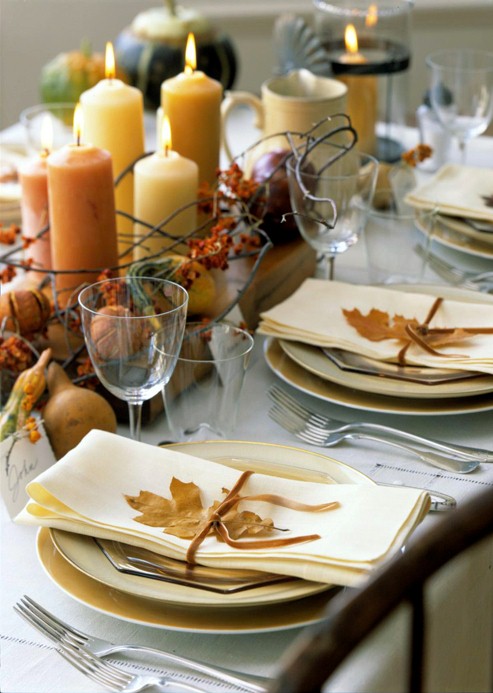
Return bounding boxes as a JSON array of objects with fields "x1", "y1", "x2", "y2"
[{"x1": 14, "y1": 595, "x2": 265, "y2": 693}]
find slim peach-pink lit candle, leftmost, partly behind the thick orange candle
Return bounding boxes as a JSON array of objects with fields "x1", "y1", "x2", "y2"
[{"x1": 19, "y1": 118, "x2": 53, "y2": 279}]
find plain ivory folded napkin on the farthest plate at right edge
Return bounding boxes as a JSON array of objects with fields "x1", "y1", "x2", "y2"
[{"x1": 405, "y1": 164, "x2": 493, "y2": 221}]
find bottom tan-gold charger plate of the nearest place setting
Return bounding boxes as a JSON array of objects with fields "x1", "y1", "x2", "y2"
[{"x1": 37, "y1": 527, "x2": 333, "y2": 635}]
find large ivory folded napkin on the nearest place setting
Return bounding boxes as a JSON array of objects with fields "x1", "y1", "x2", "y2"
[{"x1": 16, "y1": 430, "x2": 429, "y2": 585}]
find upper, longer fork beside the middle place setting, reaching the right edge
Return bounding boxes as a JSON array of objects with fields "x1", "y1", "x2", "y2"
[{"x1": 268, "y1": 385, "x2": 493, "y2": 462}]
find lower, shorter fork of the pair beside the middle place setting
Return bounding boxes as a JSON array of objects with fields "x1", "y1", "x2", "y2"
[{"x1": 269, "y1": 404, "x2": 480, "y2": 474}]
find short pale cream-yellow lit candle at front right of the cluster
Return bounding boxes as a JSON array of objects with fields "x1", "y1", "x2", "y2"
[{"x1": 134, "y1": 117, "x2": 199, "y2": 260}]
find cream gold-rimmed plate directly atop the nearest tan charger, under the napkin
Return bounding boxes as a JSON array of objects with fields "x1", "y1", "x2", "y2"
[{"x1": 40, "y1": 441, "x2": 373, "y2": 609}]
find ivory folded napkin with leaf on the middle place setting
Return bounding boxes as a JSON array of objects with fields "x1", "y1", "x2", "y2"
[{"x1": 258, "y1": 278, "x2": 493, "y2": 374}]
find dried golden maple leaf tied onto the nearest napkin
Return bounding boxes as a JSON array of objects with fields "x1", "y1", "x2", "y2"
[{"x1": 125, "y1": 477, "x2": 274, "y2": 539}]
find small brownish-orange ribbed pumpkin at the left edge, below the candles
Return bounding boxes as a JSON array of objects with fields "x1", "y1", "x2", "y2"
[{"x1": 0, "y1": 289, "x2": 51, "y2": 336}]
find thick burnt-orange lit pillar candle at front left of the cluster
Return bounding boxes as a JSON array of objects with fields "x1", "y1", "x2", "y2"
[{"x1": 48, "y1": 106, "x2": 118, "y2": 306}]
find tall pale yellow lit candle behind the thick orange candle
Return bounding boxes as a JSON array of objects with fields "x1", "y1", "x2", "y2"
[{"x1": 80, "y1": 43, "x2": 144, "y2": 262}]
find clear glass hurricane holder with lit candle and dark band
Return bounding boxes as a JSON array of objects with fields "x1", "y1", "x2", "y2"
[{"x1": 313, "y1": 0, "x2": 414, "y2": 162}]
